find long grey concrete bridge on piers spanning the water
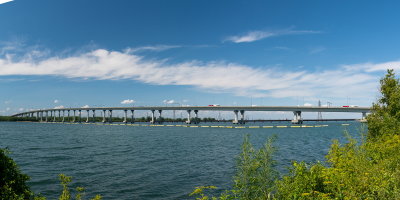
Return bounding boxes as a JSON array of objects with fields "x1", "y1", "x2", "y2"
[{"x1": 12, "y1": 106, "x2": 371, "y2": 124}]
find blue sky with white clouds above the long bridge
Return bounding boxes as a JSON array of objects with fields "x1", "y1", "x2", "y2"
[{"x1": 0, "y1": 0, "x2": 400, "y2": 118}]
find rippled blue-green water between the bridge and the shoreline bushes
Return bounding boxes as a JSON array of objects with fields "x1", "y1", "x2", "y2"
[{"x1": 0, "y1": 122, "x2": 360, "y2": 199}]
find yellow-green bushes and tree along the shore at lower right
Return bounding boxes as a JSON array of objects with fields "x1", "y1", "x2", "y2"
[{"x1": 191, "y1": 70, "x2": 400, "y2": 200}]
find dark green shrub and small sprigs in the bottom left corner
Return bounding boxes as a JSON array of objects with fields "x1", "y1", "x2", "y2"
[{"x1": 0, "y1": 149, "x2": 101, "y2": 200}]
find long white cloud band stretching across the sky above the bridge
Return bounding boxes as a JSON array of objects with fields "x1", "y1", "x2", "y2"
[{"x1": 0, "y1": 49, "x2": 390, "y2": 103}]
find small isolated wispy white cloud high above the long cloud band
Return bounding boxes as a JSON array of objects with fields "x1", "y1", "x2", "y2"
[{"x1": 224, "y1": 28, "x2": 321, "y2": 43}]
